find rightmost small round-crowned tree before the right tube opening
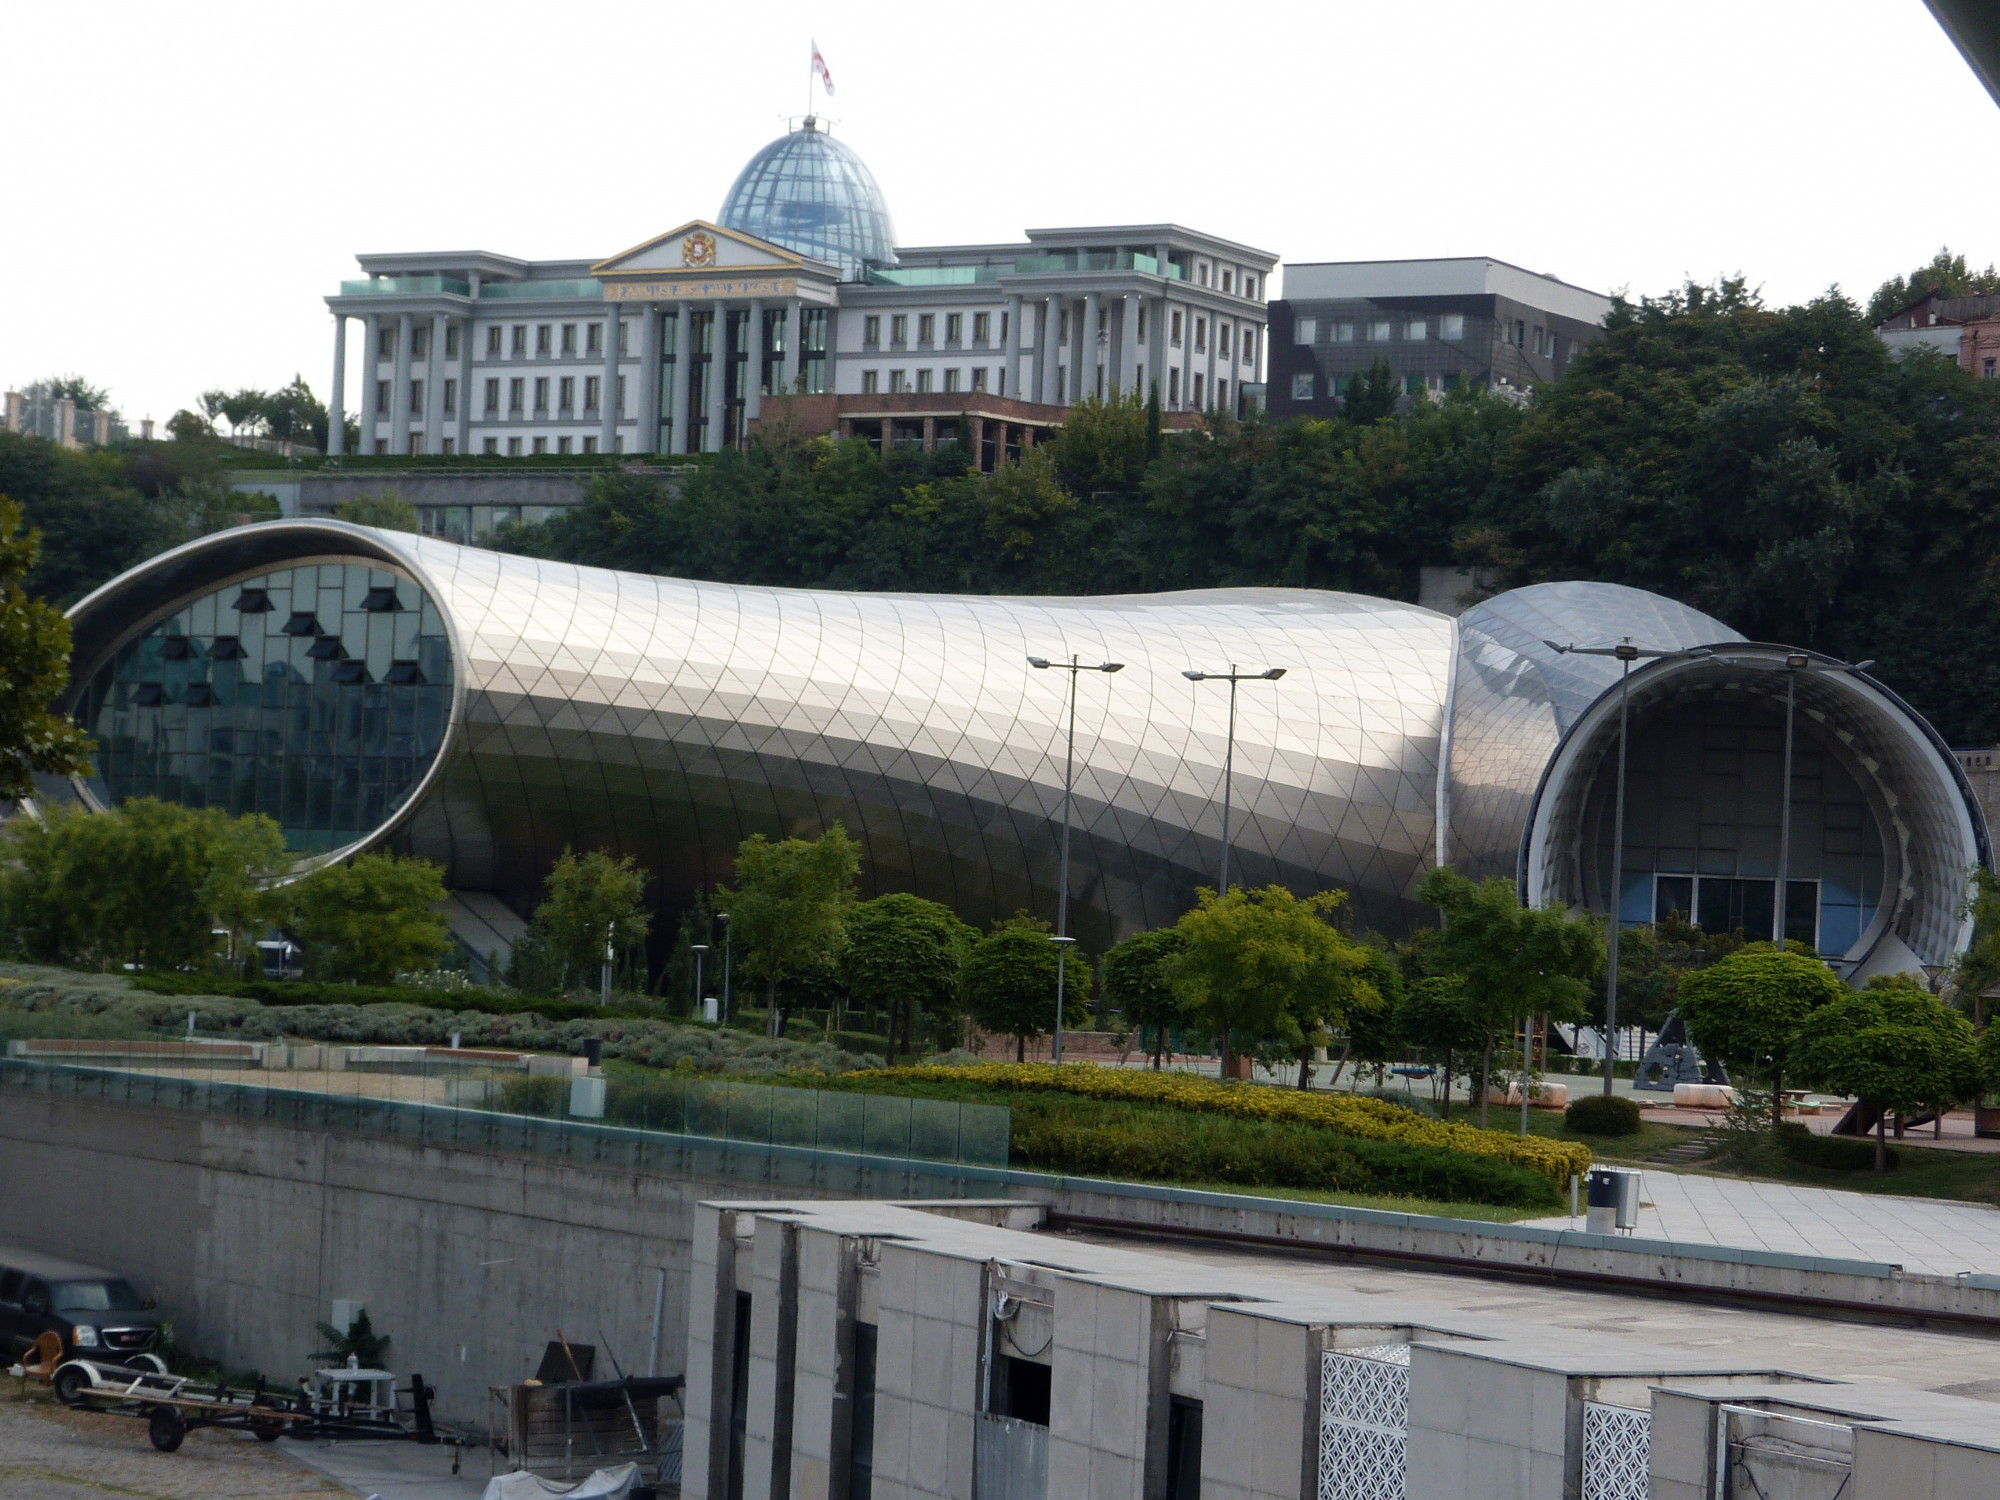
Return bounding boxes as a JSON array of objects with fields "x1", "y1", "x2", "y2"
[{"x1": 1792, "y1": 974, "x2": 1982, "y2": 1172}]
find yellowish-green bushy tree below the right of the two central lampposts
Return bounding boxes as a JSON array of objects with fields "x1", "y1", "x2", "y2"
[{"x1": 1170, "y1": 886, "x2": 1382, "y2": 1078}]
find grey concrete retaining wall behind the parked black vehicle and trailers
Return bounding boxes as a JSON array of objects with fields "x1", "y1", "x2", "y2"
[{"x1": 0, "y1": 1088, "x2": 796, "y2": 1424}]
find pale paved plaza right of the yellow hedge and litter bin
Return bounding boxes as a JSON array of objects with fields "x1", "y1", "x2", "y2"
[{"x1": 1528, "y1": 1166, "x2": 2000, "y2": 1276}]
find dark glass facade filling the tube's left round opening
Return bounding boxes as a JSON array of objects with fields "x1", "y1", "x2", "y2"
[{"x1": 76, "y1": 562, "x2": 452, "y2": 854}]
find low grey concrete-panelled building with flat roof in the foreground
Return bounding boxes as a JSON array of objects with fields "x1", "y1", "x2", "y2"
[{"x1": 682, "y1": 1200, "x2": 2000, "y2": 1500}]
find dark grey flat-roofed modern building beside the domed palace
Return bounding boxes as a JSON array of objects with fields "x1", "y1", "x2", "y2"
[{"x1": 1268, "y1": 256, "x2": 1612, "y2": 416}]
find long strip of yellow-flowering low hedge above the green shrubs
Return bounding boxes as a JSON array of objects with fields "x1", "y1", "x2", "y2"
[{"x1": 870, "y1": 1062, "x2": 1590, "y2": 1186}]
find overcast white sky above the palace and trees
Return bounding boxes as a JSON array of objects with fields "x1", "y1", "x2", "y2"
[{"x1": 0, "y1": 0, "x2": 2000, "y2": 422}]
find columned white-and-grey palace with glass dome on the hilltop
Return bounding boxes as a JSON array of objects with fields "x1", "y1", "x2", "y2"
[{"x1": 326, "y1": 118, "x2": 1276, "y2": 456}]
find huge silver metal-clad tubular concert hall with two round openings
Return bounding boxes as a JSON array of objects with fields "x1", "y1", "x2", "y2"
[{"x1": 64, "y1": 520, "x2": 1988, "y2": 980}]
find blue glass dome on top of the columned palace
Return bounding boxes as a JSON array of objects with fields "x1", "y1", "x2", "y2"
[{"x1": 718, "y1": 116, "x2": 896, "y2": 282}]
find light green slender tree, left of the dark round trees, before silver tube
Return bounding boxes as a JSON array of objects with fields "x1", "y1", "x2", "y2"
[{"x1": 716, "y1": 822, "x2": 860, "y2": 1036}]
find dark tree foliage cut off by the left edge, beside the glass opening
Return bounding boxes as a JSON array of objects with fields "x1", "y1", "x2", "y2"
[{"x1": 0, "y1": 496, "x2": 90, "y2": 800}]
